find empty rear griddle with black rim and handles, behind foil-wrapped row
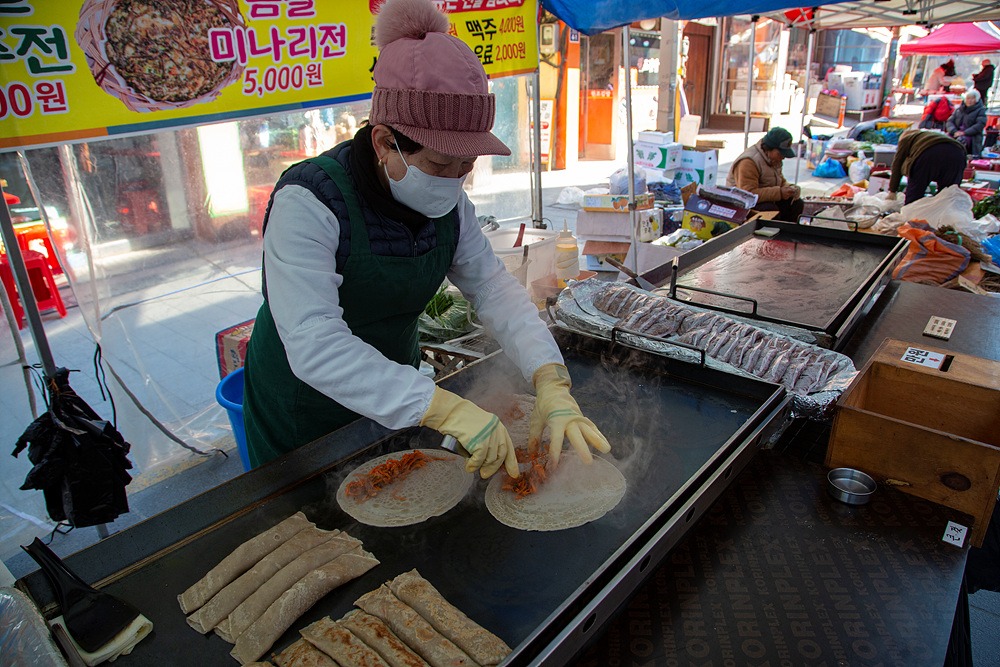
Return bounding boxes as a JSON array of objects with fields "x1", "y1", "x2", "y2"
[{"x1": 642, "y1": 220, "x2": 908, "y2": 349}]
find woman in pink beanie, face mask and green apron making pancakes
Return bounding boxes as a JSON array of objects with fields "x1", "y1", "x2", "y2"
[{"x1": 243, "y1": 0, "x2": 610, "y2": 478}]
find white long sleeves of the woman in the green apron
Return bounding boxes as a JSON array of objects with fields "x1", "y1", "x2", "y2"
[{"x1": 264, "y1": 185, "x2": 563, "y2": 428}]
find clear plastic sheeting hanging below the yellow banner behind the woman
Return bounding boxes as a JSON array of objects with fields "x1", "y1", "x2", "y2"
[{"x1": 0, "y1": 76, "x2": 531, "y2": 556}]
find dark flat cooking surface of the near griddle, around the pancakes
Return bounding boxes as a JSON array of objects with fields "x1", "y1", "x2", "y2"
[{"x1": 29, "y1": 337, "x2": 781, "y2": 665}]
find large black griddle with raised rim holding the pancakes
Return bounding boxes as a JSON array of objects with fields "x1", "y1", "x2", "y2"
[{"x1": 18, "y1": 329, "x2": 788, "y2": 665}]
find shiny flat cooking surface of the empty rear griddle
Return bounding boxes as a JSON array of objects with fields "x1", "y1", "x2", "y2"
[{"x1": 677, "y1": 230, "x2": 887, "y2": 329}]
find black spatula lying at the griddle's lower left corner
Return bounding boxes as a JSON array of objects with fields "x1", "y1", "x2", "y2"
[{"x1": 21, "y1": 537, "x2": 139, "y2": 653}]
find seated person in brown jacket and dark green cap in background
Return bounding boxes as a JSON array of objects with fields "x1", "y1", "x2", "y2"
[{"x1": 726, "y1": 127, "x2": 804, "y2": 222}]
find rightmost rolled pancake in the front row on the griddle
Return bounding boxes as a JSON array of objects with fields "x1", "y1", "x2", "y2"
[{"x1": 389, "y1": 570, "x2": 510, "y2": 665}]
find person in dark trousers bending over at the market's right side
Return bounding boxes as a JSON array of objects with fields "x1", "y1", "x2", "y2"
[{"x1": 888, "y1": 130, "x2": 966, "y2": 204}]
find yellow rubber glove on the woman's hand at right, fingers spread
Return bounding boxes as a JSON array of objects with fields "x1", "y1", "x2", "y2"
[{"x1": 528, "y1": 364, "x2": 611, "y2": 465}]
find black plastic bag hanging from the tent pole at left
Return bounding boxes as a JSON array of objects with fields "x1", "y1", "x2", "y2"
[{"x1": 13, "y1": 368, "x2": 132, "y2": 528}]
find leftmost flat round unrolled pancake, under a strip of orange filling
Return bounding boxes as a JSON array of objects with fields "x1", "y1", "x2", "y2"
[{"x1": 337, "y1": 449, "x2": 475, "y2": 528}]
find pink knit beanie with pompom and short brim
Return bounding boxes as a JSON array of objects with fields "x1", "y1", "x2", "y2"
[{"x1": 368, "y1": 0, "x2": 510, "y2": 157}]
